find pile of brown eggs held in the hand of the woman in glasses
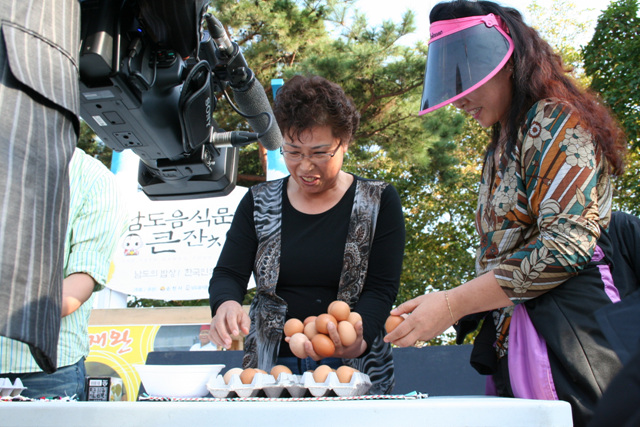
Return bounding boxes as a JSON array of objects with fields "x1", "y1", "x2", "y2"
[{"x1": 284, "y1": 301, "x2": 362, "y2": 359}]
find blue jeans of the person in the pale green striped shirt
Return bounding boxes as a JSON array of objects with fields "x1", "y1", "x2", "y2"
[{"x1": 2, "y1": 357, "x2": 87, "y2": 400}]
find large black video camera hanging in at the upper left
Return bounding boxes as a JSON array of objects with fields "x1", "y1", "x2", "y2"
[{"x1": 80, "y1": 0, "x2": 282, "y2": 200}]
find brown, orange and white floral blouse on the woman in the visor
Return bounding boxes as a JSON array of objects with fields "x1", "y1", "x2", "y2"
[{"x1": 476, "y1": 99, "x2": 612, "y2": 354}]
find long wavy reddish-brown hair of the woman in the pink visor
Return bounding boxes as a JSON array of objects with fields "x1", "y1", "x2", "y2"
[{"x1": 429, "y1": 0, "x2": 626, "y2": 175}]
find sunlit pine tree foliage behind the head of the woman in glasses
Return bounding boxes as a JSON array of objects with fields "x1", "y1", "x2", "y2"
[{"x1": 212, "y1": 0, "x2": 436, "y2": 174}]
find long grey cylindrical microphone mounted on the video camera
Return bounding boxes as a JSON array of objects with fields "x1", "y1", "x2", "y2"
[{"x1": 205, "y1": 14, "x2": 283, "y2": 150}]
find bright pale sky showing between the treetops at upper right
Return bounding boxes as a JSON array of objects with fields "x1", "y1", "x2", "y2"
[{"x1": 356, "y1": 0, "x2": 611, "y2": 45}]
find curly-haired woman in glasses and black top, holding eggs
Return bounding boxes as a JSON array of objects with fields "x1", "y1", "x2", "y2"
[{"x1": 209, "y1": 76, "x2": 405, "y2": 394}]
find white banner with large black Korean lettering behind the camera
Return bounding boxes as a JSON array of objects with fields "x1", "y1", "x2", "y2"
[{"x1": 107, "y1": 150, "x2": 255, "y2": 301}]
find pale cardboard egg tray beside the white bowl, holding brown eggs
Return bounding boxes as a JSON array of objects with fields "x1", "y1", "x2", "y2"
[{"x1": 207, "y1": 372, "x2": 371, "y2": 398}]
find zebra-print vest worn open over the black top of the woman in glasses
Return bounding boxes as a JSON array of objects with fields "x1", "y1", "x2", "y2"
[{"x1": 243, "y1": 177, "x2": 395, "y2": 394}]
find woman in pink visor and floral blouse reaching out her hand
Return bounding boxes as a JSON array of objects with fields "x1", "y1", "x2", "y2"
[{"x1": 385, "y1": 0, "x2": 625, "y2": 426}]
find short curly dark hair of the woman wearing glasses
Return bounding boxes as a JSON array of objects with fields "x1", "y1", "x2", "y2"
[{"x1": 273, "y1": 75, "x2": 360, "y2": 149}]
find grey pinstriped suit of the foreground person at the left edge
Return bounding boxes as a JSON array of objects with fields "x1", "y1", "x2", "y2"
[{"x1": 0, "y1": 0, "x2": 80, "y2": 372}]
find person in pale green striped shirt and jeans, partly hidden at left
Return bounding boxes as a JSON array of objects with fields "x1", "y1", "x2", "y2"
[{"x1": 0, "y1": 148, "x2": 126, "y2": 400}]
